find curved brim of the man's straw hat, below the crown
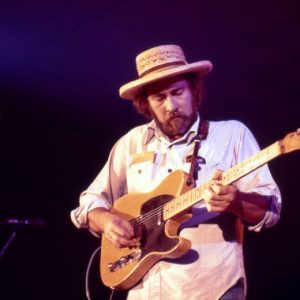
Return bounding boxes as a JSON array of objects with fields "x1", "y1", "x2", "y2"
[{"x1": 119, "y1": 60, "x2": 213, "y2": 100}]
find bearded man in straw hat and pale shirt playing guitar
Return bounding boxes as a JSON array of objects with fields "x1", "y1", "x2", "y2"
[{"x1": 71, "y1": 45, "x2": 281, "y2": 300}]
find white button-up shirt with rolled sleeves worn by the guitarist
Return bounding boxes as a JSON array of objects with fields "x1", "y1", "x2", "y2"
[{"x1": 71, "y1": 119, "x2": 281, "y2": 300}]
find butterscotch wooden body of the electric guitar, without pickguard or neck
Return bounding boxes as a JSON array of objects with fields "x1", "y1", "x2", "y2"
[{"x1": 100, "y1": 171, "x2": 191, "y2": 289}]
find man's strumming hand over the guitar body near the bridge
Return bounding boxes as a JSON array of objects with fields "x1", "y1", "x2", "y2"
[{"x1": 87, "y1": 207, "x2": 137, "y2": 247}]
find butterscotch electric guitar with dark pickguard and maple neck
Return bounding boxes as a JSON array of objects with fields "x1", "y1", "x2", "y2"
[{"x1": 100, "y1": 129, "x2": 300, "y2": 290}]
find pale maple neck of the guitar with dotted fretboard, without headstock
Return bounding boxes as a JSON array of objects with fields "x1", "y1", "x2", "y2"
[{"x1": 163, "y1": 141, "x2": 281, "y2": 221}]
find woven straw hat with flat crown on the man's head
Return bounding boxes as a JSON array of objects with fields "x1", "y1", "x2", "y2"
[{"x1": 119, "y1": 45, "x2": 213, "y2": 100}]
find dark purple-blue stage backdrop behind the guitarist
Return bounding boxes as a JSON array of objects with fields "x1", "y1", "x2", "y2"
[{"x1": 0, "y1": 0, "x2": 300, "y2": 300}]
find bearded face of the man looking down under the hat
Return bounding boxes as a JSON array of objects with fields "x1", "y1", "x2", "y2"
[{"x1": 146, "y1": 77, "x2": 197, "y2": 140}]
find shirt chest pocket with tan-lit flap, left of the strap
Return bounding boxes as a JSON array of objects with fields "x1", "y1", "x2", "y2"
[{"x1": 126, "y1": 151, "x2": 156, "y2": 192}]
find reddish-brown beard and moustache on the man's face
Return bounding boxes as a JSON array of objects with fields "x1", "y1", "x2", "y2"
[{"x1": 152, "y1": 108, "x2": 198, "y2": 140}]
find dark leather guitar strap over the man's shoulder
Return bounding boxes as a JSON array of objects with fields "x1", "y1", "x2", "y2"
[{"x1": 186, "y1": 119, "x2": 209, "y2": 185}]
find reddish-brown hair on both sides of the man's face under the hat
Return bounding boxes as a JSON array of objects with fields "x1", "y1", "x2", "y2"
[{"x1": 133, "y1": 74, "x2": 205, "y2": 119}]
